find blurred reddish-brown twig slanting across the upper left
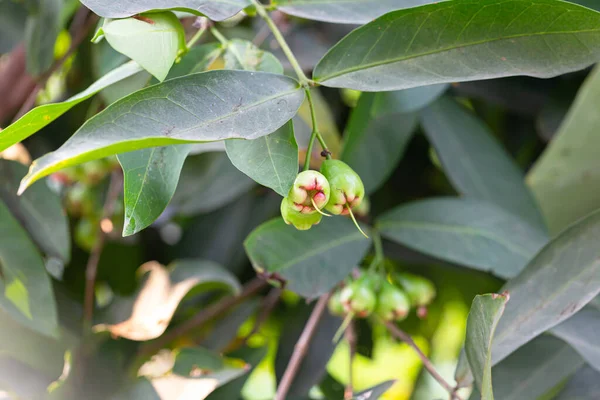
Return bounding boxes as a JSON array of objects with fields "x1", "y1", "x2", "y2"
[{"x1": 13, "y1": 6, "x2": 98, "y2": 123}]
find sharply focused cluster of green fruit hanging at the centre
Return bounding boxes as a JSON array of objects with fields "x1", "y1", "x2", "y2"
[{"x1": 281, "y1": 160, "x2": 365, "y2": 230}]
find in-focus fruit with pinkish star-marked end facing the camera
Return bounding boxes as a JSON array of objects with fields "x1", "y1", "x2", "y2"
[{"x1": 288, "y1": 171, "x2": 330, "y2": 214}]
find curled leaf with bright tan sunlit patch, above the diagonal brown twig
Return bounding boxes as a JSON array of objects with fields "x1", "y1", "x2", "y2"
[{"x1": 94, "y1": 259, "x2": 240, "y2": 341}]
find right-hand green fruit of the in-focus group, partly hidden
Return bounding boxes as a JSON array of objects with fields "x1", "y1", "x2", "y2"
[{"x1": 321, "y1": 160, "x2": 365, "y2": 215}]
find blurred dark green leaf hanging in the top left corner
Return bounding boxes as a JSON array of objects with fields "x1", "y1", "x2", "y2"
[{"x1": 25, "y1": 0, "x2": 63, "y2": 75}]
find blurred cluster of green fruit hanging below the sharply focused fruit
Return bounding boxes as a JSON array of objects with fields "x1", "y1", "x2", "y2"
[{"x1": 329, "y1": 272, "x2": 436, "y2": 322}]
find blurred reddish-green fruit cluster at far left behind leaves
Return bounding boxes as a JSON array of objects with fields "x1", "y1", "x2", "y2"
[{"x1": 52, "y1": 157, "x2": 123, "y2": 251}]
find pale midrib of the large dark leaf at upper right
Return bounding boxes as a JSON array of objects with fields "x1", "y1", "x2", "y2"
[{"x1": 314, "y1": 28, "x2": 600, "y2": 82}]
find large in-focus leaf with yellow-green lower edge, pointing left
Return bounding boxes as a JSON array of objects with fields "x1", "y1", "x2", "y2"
[{"x1": 21, "y1": 71, "x2": 304, "y2": 192}]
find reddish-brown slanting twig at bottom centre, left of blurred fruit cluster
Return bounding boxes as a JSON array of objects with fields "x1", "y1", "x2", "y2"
[{"x1": 275, "y1": 293, "x2": 330, "y2": 400}]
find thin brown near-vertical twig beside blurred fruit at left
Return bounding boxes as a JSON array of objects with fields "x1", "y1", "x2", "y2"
[{"x1": 83, "y1": 171, "x2": 122, "y2": 327}]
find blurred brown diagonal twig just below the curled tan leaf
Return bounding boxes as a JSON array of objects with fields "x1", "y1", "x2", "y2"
[{"x1": 140, "y1": 277, "x2": 269, "y2": 356}]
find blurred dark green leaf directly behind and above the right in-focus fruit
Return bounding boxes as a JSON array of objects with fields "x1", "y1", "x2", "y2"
[{"x1": 341, "y1": 92, "x2": 417, "y2": 194}]
